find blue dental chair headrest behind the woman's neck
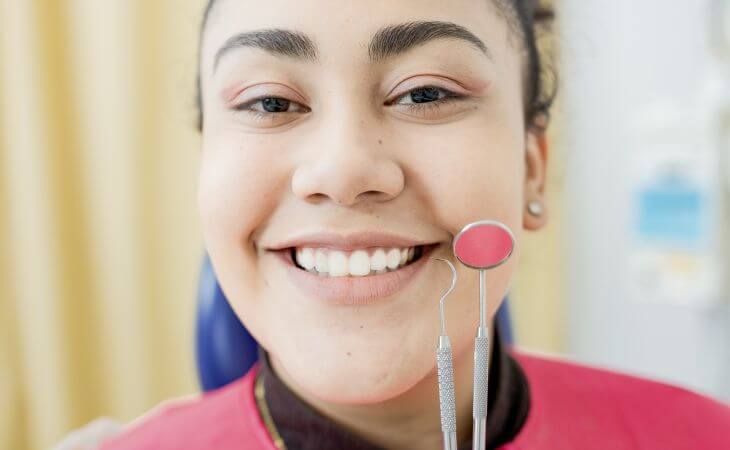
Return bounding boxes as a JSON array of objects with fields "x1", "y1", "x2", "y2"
[{"x1": 195, "y1": 255, "x2": 513, "y2": 391}]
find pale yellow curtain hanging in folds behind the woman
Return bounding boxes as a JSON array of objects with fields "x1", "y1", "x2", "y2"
[{"x1": 0, "y1": 0, "x2": 560, "y2": 449}]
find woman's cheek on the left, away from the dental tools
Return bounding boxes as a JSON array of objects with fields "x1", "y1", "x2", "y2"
[{"x1": 198, "y1": 133, "x2": 288, "y2": 308}]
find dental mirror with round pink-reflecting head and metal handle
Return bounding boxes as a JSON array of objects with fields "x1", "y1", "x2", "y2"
[{"x1": 453, "y1": 220, "x2": 515, "y2": 450}]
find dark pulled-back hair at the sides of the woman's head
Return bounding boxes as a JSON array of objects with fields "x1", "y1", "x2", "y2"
[{"x1": 196, "y1": 0, "x2": 558, "y2": 131}]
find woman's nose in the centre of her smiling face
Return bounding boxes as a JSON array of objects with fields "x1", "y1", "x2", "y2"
[{"x1": 292, "y1": 116, "x2": 405, "y2": 206}]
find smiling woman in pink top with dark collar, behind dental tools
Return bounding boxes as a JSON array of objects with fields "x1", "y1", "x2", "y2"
[{"x1": 58, "y1": 0, "x2": 730, "y2": 450}]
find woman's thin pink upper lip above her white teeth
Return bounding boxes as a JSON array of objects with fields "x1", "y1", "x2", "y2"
[{"x1": 269, "y1": 231, "x2": 434, "y2": 251}]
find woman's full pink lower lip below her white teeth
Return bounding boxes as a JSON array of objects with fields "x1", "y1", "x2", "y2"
[{"x1": 275, "y1": 245, "x2": 435, "y2": 305}]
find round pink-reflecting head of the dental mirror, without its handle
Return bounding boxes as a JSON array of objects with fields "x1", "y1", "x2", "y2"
[{"x1": 454, "y1": 220, "x2": 515, "y2": 269}]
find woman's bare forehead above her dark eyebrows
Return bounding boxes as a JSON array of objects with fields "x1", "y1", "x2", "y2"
[{"x1": 201, "y1": 0, "x2": 508, "y2": 75}]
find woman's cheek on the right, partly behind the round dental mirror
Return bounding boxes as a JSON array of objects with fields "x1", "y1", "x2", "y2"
[{"x1": 398, "y1": 115, "x2": 525, "y2": 326}]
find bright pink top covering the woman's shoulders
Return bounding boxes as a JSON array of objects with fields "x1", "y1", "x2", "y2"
[{"x1": 100, "y1": 349, "x2": 730, "y2": 450}]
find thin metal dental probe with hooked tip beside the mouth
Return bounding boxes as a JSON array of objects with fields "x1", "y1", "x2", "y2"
[{"x1": 431, "y1": 258, "x2": 457, "y2": 450}]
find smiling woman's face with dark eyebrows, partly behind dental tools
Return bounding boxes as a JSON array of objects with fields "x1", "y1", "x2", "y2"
[{"x1": 199, "y1": 0, "x2": 546, "y2": 403}]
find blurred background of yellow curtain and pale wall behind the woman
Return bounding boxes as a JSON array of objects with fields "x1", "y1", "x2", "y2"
[{"x1": 0, "y1": 0, "x2": 730, "y2": 449}]
